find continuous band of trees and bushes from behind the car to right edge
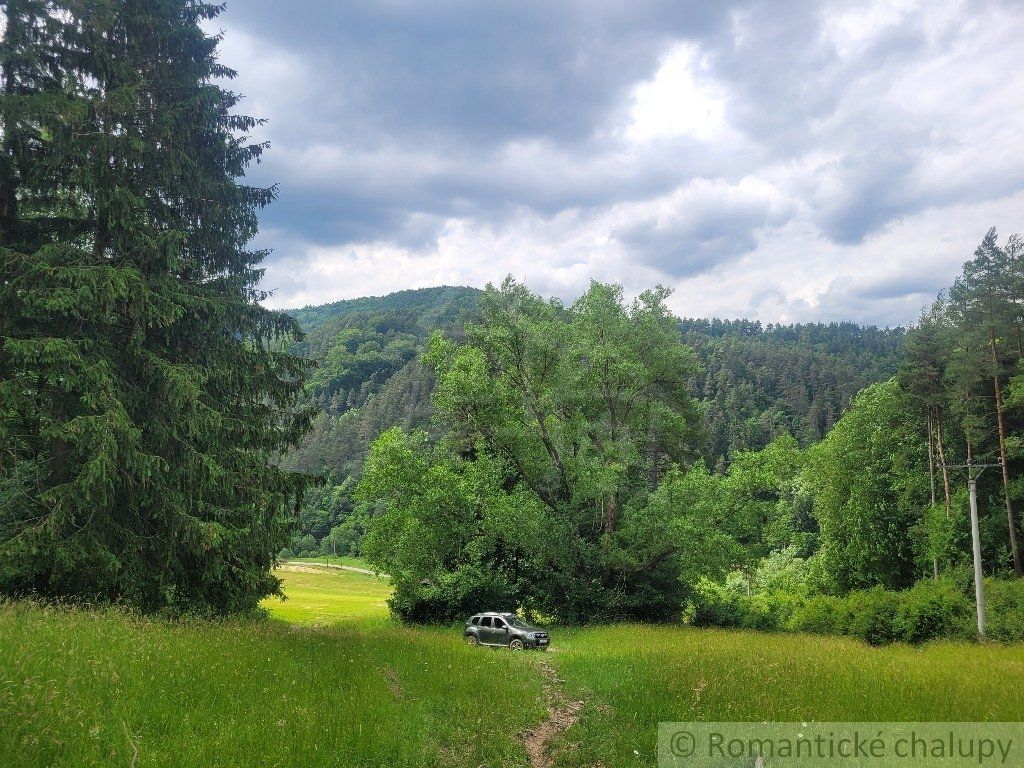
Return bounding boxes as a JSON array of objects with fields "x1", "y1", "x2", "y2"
[{"x1": 344, "y1": 232, "x2": 1024, "y2": 642}]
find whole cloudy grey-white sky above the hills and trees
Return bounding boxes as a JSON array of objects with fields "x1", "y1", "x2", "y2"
[{"x1": 215, "y1": 0, "x2": 1024, "y2": 325}]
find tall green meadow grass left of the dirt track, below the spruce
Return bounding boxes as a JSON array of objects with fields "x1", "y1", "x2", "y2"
[{"x1": 0, "y1": 571, "x2": 542, "y2": 768}]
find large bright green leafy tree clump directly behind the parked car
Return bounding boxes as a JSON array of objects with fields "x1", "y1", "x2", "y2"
[{"x1": 359, "y1": 280, "x2": 715, "y2": 621}]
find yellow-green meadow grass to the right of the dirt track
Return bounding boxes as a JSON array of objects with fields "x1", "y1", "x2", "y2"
[{"x1": 554, "y1": 625, "x2": 1024, "y2": 766}]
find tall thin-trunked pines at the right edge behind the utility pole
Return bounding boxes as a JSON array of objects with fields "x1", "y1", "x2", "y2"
[{"x1": 900, "y1": 229, "x2": 1024, "y2": 577}]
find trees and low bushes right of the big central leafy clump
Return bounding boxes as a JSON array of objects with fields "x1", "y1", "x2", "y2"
[{"x1": 691, "y1": 230, "x2": 1024, "y2": 641}]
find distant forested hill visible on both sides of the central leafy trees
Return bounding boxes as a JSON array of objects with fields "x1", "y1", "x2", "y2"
[{"x1": 284, "y1": 287, "x2": 903, "y2": 551}]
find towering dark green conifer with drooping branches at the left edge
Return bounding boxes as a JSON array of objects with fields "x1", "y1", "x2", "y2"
[{"x1": 0, "y1": 0, "x2": 309, "y2": 612}]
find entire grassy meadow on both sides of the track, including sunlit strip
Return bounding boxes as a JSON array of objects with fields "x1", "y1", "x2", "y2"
[{"x1": 0, "y1": 562, "x2": 1024, "y2": 768}]
